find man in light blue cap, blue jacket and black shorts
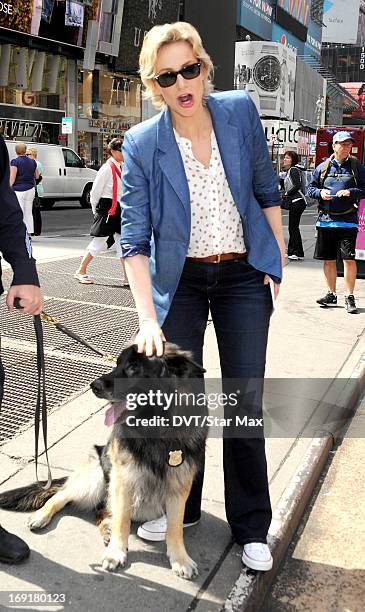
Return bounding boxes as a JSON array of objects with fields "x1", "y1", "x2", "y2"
[{"x1": 308, "y1": 131, "x2": 365, "y2": 314}]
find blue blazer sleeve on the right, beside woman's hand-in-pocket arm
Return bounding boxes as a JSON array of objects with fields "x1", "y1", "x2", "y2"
[{"x1": 249, "y1": 100, "x2": 281, "y2": 208}]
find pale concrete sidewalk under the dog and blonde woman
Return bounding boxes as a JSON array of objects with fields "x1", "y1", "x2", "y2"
[{"x1": 0, "y1": 232, "x2": 365, "y2": 612}]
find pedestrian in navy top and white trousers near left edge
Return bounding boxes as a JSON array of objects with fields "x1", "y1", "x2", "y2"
[{"x1": 10, "y1": 142, "x2": 39, "y2": 236}]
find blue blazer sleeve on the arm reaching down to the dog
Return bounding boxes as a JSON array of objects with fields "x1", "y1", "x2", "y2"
[{"x1": 120, "y1": 132, "x2": 152, "y2": 257}]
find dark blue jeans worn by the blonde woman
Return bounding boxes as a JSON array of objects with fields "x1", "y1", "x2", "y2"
[{"x1": 163, "y1": 258, "x2": 272, "y2": 544}]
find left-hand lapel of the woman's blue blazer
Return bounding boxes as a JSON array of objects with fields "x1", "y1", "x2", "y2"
[{"x1": 157, "y1": 111, "x2": 190, "y2": 221}]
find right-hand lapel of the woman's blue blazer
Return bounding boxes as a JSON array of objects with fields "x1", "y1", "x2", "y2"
[{"x1": 208, "y1": 96, "x2": 241, "y2": 204}]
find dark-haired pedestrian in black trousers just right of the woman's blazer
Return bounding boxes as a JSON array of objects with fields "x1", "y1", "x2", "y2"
[{"x1": 283, "y1": 151, "x2": 306, "y2": 261}]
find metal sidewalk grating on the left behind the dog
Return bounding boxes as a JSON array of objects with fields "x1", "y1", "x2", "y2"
[{"x1": 0, "y1": 256, "x2": 138, "y2": 444}]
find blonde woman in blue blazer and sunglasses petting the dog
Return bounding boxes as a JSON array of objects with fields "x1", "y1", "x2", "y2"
[{"x1": 121, "y1": 22, "x2": 285, "y2": 570}]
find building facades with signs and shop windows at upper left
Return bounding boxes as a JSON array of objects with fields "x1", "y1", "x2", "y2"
[{"x1": 0, "y1": 0, "x2": 180, "y2": 168}]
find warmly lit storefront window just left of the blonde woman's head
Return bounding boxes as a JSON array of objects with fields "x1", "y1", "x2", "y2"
[{"x1": 78, "y1": 70, "x2": 141, "y2": 168}]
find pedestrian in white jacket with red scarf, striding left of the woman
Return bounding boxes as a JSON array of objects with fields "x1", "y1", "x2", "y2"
[{"x1": 74, "y1": 138, "x2": 128, "y2": 286}]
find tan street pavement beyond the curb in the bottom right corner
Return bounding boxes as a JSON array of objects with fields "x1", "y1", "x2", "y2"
[{"x1": 264, "y1": 399, "x2": 365, "y2": 612}]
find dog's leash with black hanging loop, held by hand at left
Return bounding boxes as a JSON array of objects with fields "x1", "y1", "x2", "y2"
[{"x1": 14, "y1": 298, "x2": 116, "y2": 490}]
